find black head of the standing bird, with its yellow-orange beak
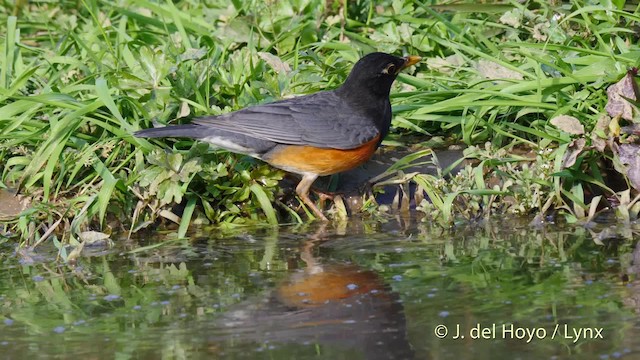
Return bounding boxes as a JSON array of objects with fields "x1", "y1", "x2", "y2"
[{"x1": 341, "y1": 52, "x2": 420, "y2": 98}]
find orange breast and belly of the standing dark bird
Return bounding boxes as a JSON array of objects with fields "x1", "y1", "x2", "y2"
[{"x1": 264, "y1": 136, "x2": 380, "y2": 176}]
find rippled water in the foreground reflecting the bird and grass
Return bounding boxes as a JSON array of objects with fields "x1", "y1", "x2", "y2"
[{"x1": 0, "y1": 215, "x2": 640, "y2": 360}]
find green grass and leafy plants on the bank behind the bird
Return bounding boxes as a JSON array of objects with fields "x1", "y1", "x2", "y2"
[{"x1": 0, "y1": 0, "x2": 640, "y2": 248}]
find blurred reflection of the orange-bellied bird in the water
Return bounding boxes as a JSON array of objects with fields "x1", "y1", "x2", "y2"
[{"x1": 215, "y1": 226, "x2": 413, "y2": 359}]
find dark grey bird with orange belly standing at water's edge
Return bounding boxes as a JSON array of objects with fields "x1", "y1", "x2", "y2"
[{"x1": 134, "y1": 52, "x2": 421, "y2": 222}]
